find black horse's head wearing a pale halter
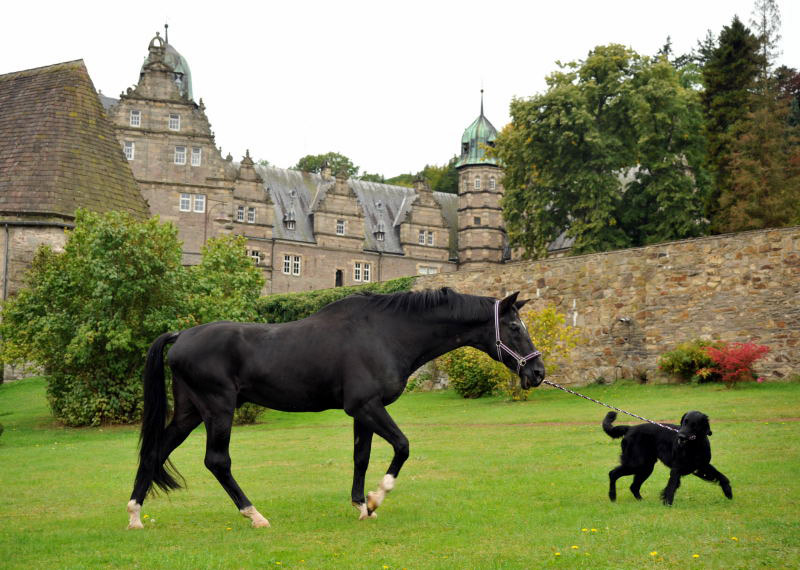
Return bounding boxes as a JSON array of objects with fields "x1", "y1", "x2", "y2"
[{"x1": 489, "y1": 291, "x2": 545, "y2": 390}]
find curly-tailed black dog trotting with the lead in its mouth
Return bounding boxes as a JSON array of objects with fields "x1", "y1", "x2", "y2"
[{"x1": 603, "y1": 412, "x2": 733, "y2": 505}]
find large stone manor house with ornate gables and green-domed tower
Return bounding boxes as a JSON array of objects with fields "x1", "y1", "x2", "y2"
[{"x1": 100, "y1": 34, "x2": 510, "y2": 293}]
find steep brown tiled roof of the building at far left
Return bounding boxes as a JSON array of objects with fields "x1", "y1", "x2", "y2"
[{"x1": 0, "y1": 60, "x2": 149, "y2": 219}]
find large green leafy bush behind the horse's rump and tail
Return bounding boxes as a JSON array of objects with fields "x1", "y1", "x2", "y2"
[{"x1": 0, "y1": 211, "x2": 263, "y2": 425}]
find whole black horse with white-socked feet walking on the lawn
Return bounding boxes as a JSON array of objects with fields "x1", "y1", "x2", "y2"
[{"x1": 128, "y1": 288, "x2": 545, "y2": 528}]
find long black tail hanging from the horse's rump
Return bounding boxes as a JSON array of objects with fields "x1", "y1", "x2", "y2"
[{"x1": 136, "y1": 333, "x2": 181, "y2": 492}]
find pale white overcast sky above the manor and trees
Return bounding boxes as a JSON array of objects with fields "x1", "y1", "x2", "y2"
[{"x1": 0, "y1": 0, "x2": 800, "y2": 177}]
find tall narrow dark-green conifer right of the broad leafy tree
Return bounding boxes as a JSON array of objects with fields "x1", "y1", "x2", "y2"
[{"x1": 703, "y1": 17, "x2": 762, "y2": 231}]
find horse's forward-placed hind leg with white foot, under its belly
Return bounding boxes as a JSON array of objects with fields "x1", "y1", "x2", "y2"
[{"x1": 204, "y1": 406, "x2": 269, "y2": 527}]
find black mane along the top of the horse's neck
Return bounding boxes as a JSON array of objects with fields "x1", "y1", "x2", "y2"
[{"x1": 348, "y1": 287, "x2": 493, "y2": 321}]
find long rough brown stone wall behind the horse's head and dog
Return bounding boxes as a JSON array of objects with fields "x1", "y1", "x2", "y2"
[{"x1": 415, "y1": 226, "x2": 800, "y2": 384}]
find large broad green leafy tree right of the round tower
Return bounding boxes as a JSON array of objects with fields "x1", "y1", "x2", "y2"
[{"x1": 494, "y1": 44, "x2": 707, "y2": 257}]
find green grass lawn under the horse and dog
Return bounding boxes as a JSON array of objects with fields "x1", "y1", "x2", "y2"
[{"x1": 0, "y1": 379, "x2": 800, "y2": 569}]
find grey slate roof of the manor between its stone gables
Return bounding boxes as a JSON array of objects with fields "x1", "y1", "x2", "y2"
[{"x1": 255, "y1": 165, "x2": 458, "y2": 258}]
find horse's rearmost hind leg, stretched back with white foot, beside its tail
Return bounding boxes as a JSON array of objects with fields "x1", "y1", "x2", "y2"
[{"x1": 128, "y1": 381, "x2": 201, "y2": 529}]
